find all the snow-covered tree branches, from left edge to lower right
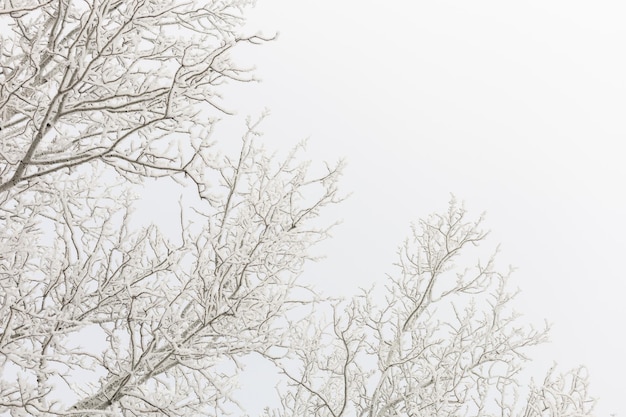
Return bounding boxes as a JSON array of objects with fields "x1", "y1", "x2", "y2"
[{"x1": 0, "y1": 0, "x2": 590, "y2": 417}]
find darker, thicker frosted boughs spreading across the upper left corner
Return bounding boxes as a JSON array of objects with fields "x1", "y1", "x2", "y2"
[{"x1": 0, "y1": 0, "x2": 264, "y2": 192}]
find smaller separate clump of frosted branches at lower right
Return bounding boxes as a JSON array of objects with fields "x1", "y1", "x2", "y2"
[{"x1": 266, "y1": 200, "x2": 590, "y2": 417}]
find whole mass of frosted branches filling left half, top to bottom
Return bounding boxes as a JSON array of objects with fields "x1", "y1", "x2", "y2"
[{"x1": 0, "y1": 0, "x2": 341, "y2": 416}]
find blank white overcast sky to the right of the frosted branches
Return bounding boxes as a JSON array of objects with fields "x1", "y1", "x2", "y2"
[{"x1": 144, "y1": 0, "x2": 626, "y2": 417}]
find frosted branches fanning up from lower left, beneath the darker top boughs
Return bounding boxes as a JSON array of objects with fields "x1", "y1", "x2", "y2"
[{"x1": 0, "y1": 119, "x2": 340, "y2": 416}]
